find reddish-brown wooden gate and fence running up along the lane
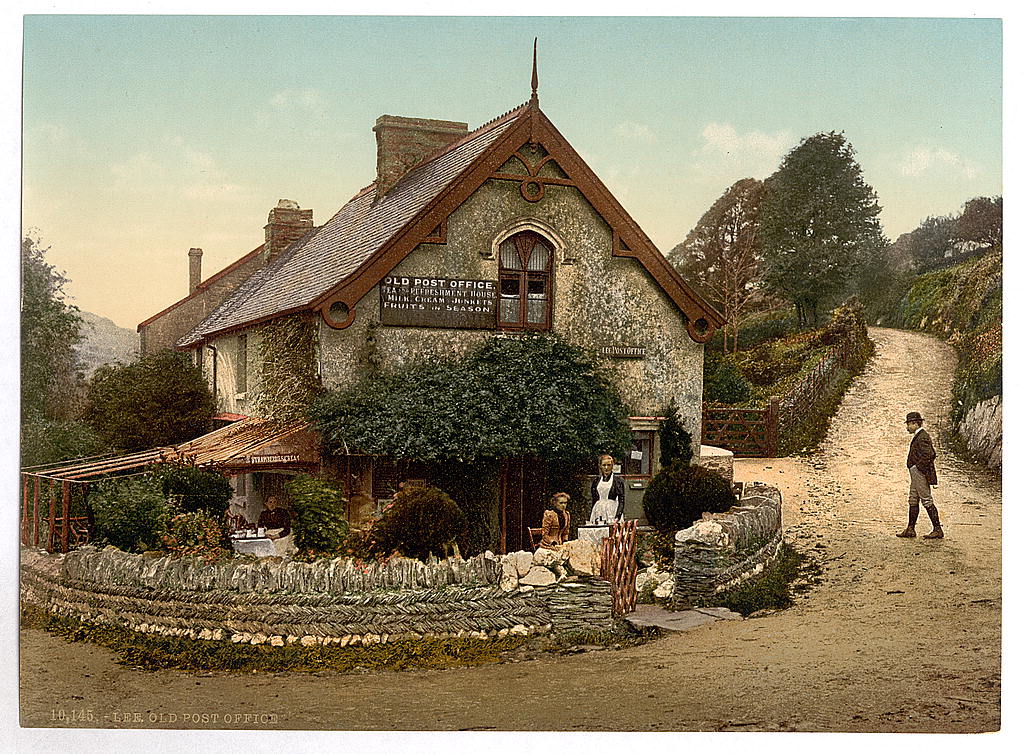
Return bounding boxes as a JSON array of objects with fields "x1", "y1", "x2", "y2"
[{"x1": 700, "y1": 340, "x2": 870, "y2": 458}]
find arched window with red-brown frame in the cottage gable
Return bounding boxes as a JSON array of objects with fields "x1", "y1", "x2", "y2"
[{"x1": 498, "y1": 231, "x2": 554, "y2": 330}]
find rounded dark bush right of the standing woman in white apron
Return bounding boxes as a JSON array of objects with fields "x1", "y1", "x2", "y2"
[{"x1": 643, "y1": 464, "x2": 736, "y2": 532}]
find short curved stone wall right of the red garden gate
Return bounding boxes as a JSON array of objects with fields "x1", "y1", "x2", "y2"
[{"x1": 673, "y1": 484, "x2": 782, "y2": 608}]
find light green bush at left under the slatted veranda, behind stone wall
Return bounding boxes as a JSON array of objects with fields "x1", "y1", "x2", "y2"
[{"x1": 89, "y1": 474, "x2": 168, "y2": 552}]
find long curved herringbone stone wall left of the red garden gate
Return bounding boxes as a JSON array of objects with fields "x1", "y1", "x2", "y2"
[{"x1": 22, "y1": 548, "x2": 615, "y2": 646}]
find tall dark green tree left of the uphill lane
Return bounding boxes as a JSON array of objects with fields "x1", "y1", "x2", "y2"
[{"x1": 761, "y1": 131, "x2": 885, "y2": 324}]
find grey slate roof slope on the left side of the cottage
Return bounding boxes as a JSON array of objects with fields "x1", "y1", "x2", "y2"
[{"x1": 177, "y1": 104, "x2": 526, "y2": 347}]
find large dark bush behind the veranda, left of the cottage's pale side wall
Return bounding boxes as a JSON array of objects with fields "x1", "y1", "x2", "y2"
[{"x1": 85, "y1": 350, "x2": 214, "y2": 451}]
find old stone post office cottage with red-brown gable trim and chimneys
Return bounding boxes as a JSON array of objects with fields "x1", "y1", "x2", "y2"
[{"x1": 139, "y1": 84, "x2": 724, "y2": 549}]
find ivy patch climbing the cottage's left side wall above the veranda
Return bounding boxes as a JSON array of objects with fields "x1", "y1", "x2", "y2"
[{"x1": 252, "y1": 317, "x2": 321, "y2": 422}]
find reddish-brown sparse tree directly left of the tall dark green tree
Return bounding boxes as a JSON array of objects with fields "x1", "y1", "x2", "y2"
[{"x1": 670, "y1": 178, "x2": 764, "y2": 350}]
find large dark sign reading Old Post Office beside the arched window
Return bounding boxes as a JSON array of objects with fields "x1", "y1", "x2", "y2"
[{"x1": 380, "y1": 276, "x2": 498, "y2": 329}]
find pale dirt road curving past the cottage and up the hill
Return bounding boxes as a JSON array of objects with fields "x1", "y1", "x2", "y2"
[{"x1": 22, "y1": 330, "x2": 1000, "y2": 732}]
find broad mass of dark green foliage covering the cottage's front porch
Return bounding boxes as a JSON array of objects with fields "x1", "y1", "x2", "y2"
[{"x1": 312, "y1": 335, "x2": 632, "y2": 462}]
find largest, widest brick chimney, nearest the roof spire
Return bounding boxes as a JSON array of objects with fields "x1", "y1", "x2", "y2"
[{"x1": 374, "y1": 115, "x2": 469, "y2": 197}]
